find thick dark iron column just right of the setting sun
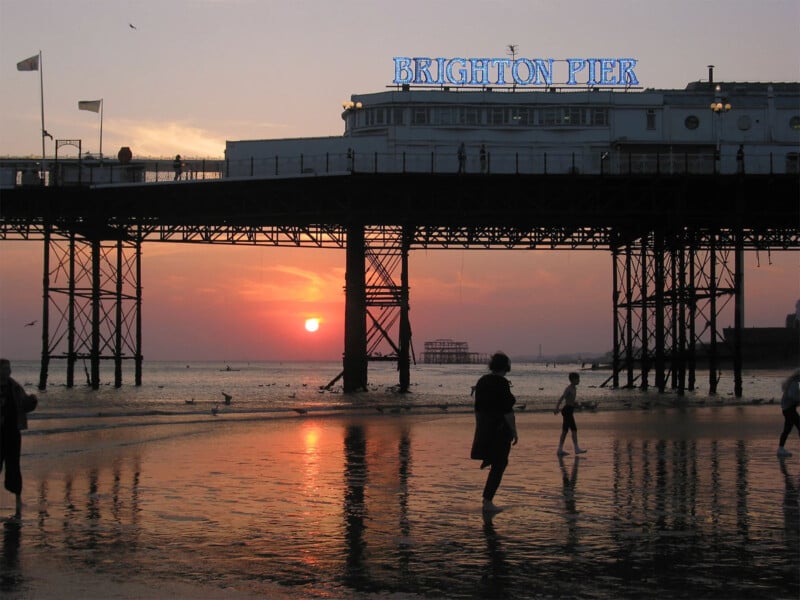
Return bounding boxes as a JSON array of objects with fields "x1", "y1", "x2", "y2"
[{"x1": 342, "y1": 225, "x2": 367, "y2": 392}]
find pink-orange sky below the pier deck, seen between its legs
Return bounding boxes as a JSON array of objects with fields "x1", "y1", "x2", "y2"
[{"x1": 0, "y1": 241, "x2": 800, "y2": 361}]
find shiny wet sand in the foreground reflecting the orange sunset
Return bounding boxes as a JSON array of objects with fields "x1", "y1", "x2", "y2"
[{"x1": 0, "y1": 405, "x2": 800, "y2": 600}]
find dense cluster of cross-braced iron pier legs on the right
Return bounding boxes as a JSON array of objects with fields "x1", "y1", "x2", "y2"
[{"x1": 609, "y1": 232, "x2": 745, "y2": 397}]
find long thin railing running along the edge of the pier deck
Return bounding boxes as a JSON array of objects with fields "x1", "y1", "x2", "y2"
[{"x1": 0, "y1": 149, "x2": 798, "y2": 187}]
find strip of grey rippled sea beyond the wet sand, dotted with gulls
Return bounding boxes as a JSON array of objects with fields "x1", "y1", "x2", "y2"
[{"x1": 7, "y1": 361, "x2": 788, "y2": 429}]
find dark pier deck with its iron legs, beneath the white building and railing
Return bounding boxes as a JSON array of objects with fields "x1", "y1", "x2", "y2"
[{"x1": 0, "y1": 164, "x2": 800, "y2": 396}]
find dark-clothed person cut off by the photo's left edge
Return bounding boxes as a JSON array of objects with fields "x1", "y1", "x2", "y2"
[{"x1": 0, "y1": 358, "x2": 38, "y2": 518}]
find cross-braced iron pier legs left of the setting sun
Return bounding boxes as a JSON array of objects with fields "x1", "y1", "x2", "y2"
[{"x1": 39, "y1": 228, "x2": 142, "y2": 389}]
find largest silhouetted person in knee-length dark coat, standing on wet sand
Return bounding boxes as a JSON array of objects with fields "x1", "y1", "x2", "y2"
[{"x1": 470, "y1": 352, "x2": 518, "y2": 512}]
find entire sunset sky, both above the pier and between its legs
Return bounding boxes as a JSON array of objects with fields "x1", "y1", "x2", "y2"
[{"x1": 0, "y1": 0, "x2": 800, "y2": 361}]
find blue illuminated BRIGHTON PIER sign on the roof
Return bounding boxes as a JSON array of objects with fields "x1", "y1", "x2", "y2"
[{"x1": 393, "y1": 56, "x2": 639, "y2": 87}]
